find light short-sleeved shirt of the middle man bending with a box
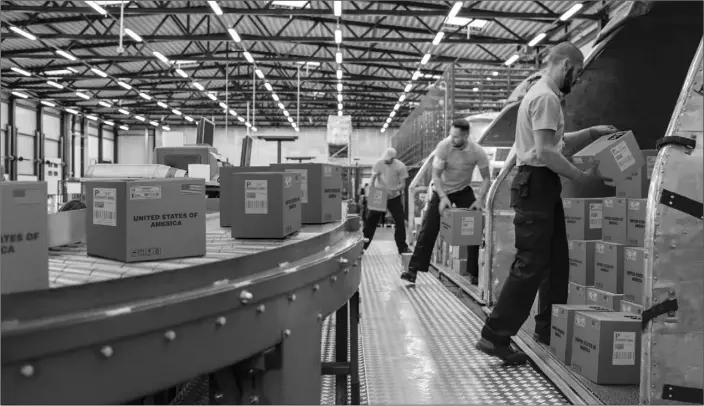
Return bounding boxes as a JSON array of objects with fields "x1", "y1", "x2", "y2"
[{"x1": 433, "y1": 137, "x2": 489, "y2": 194}]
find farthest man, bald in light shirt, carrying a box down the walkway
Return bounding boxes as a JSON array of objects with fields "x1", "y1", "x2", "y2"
[{"x1": 364, "y1": 148, "x2": 410, "y2": 254}]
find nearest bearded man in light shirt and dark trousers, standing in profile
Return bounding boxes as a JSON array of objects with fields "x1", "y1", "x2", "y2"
[{"x1": 476, "y1": 42, "x2": 616, "y2": 364}]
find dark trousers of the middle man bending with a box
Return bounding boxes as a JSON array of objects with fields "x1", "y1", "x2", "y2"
[{"x1": 408, "y1": 186, "x2": 479, "y2": 277}]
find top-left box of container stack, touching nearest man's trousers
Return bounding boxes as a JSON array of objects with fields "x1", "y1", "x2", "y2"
[{"x1": 562, "y1": 199, "x2": 602, "y2": 240}]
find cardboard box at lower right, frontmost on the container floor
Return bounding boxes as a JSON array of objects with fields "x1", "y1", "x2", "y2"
[{"x1": 572, "y1": 312, "x2": 641, "y2": 385}]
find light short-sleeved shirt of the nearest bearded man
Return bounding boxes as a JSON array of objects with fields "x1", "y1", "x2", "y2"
[{"x1": 513, "y1": 76, "x2": 565, "y2": 166}]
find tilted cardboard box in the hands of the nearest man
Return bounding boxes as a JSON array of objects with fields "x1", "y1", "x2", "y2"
[{"x1": 572, "y1": 131, "x2": 645, "y2": 184}]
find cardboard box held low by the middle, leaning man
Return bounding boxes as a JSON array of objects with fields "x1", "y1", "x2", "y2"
[{"x1": 440, "y1": 208, "x2": 484, "y2": 246}]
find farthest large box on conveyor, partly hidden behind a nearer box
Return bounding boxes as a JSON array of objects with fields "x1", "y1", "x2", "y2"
[{"x1": 271, "y1": 163, "x2": 342, "y2": 224}]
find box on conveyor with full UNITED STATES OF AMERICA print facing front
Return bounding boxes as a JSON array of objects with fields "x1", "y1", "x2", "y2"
[{"x1": 84, "y1": 178, "x2": 205, "y2": 262}]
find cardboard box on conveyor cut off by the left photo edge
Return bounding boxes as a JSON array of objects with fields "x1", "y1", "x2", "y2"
[{"x1": 0, "y1": 182, "x2": 49, "y2": 294}]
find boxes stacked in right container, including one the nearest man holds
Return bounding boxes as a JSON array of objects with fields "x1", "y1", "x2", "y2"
[{"x1": 550, "y1": 132, "x2": 657, "y2": 384}]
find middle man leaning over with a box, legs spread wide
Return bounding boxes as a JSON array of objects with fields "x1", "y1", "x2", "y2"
[{"x1": 401, "y1": 119, "x2": 491, "y2": 284}]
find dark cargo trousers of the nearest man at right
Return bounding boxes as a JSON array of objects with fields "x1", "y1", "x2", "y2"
[{"x1": 482, "y1": 166, "x2": 569, "y2": 345}]
